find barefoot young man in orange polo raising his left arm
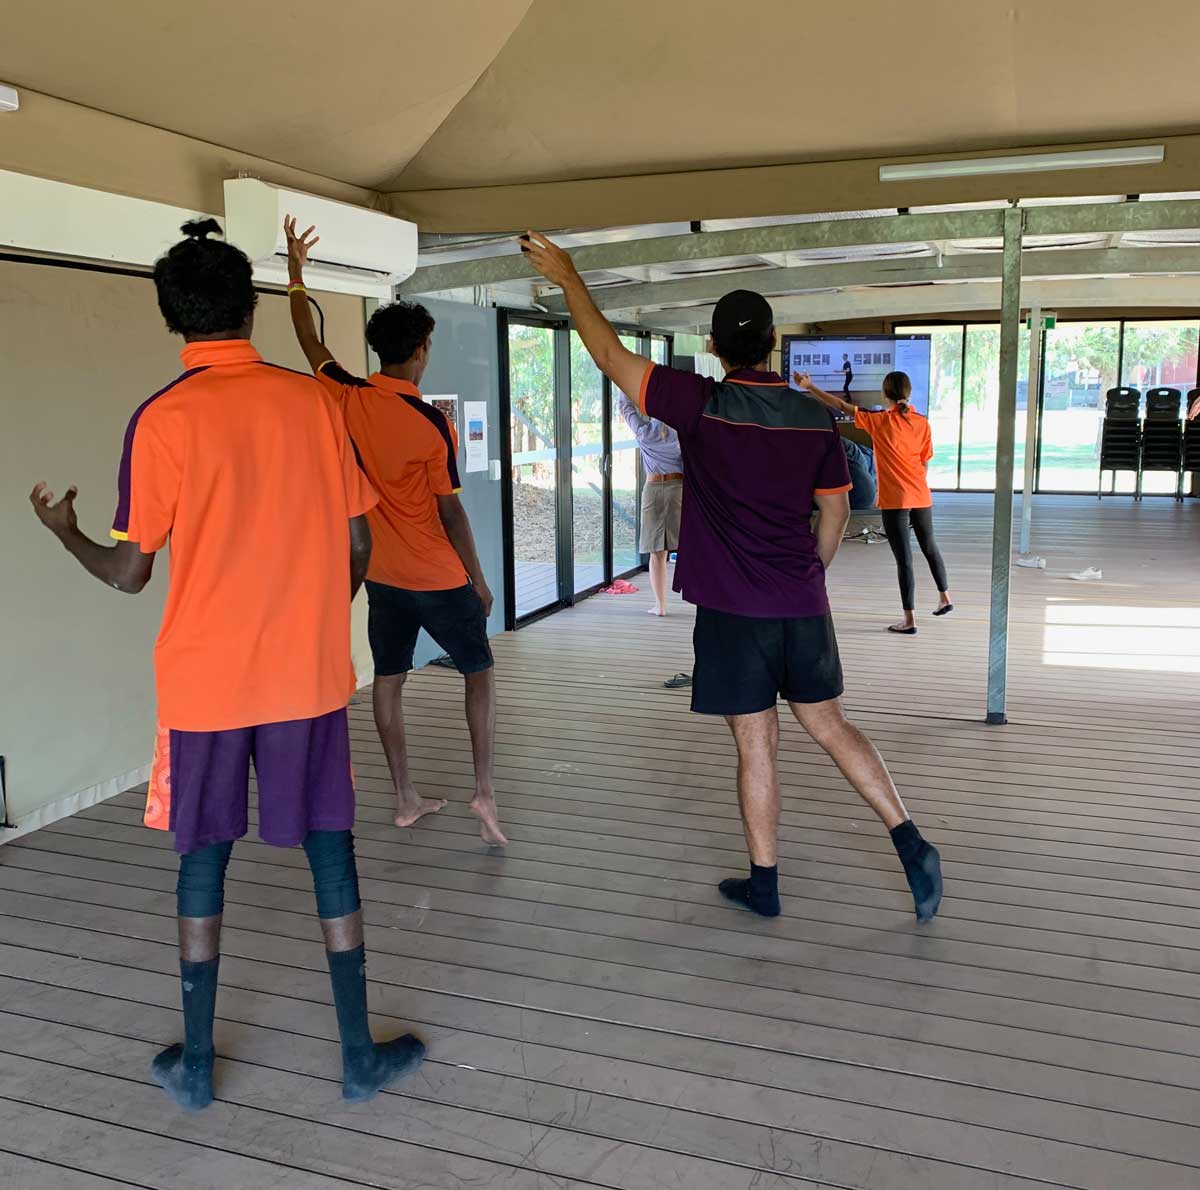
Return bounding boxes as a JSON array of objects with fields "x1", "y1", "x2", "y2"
[{"x1": 283, "y1": 217, "x2": 508, "y2": 847}]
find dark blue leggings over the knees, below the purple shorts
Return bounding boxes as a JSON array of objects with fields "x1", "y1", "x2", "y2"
[{"x1": 175, "y1": 830, "x2": 360, "y2": 920}]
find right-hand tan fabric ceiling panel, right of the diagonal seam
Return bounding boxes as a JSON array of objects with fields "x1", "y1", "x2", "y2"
[{"x1": 391, "y1": 0, "x2": 1200, "y2": 190}]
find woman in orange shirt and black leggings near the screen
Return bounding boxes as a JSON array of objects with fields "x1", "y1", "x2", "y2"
[{"x1": 792, "y1": 372, "x2": 954, "y2": 636}]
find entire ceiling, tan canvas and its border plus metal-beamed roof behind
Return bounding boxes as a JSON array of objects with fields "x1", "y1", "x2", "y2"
[{"x1": 7, "y1": 0, "x2": 1200, "y2": 325}]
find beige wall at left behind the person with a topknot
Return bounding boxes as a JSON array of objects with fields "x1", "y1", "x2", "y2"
[{"x1": 0, "y1": 260, "x2": 371, "y2": 840}]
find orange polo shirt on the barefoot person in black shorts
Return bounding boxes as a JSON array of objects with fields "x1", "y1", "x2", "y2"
[{"x1": 317, "y1": 360, "x2": 467, "y2": 591}]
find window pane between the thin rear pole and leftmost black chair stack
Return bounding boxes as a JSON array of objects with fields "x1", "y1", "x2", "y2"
[{"x1": 1038, "y1": 323, "x2": 1118, "y2": 492}]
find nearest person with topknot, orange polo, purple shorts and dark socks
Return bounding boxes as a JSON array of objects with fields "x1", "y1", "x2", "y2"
[{"x1": 30, "y1": 220, "x2": 425, "y2": 1110}]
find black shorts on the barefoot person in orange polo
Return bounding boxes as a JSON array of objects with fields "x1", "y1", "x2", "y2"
[{"x1": 366, "y1": 582, "x2": 492, "y2": 678}]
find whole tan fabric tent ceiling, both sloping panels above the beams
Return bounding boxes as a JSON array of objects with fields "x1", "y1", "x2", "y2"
[{"x1": 0, "y1": 0, "x2": 1200, "y2": 202}]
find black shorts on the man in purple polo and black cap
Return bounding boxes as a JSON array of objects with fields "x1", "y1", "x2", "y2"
[{"x1": 691, "y1": 607, "x2": 842, "y2": 715}]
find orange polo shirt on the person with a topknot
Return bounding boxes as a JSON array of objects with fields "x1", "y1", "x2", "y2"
[{"x1": 112, "y1": 339, "x2": 378, "y2": 732}]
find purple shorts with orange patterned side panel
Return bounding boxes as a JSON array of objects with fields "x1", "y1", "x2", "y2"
[{"x1": 145, "y1": 707, "x2": 354, "y2": 855}]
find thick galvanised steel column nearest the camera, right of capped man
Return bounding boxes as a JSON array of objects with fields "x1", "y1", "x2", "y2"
[{"x1": 988, "y1": 206, "x2": 1025, "y2": 723}]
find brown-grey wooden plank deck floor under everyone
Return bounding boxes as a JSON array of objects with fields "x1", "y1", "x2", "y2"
[{"x1": 0, "y1": 499, "x2": 1200, "y2": 1190}]
